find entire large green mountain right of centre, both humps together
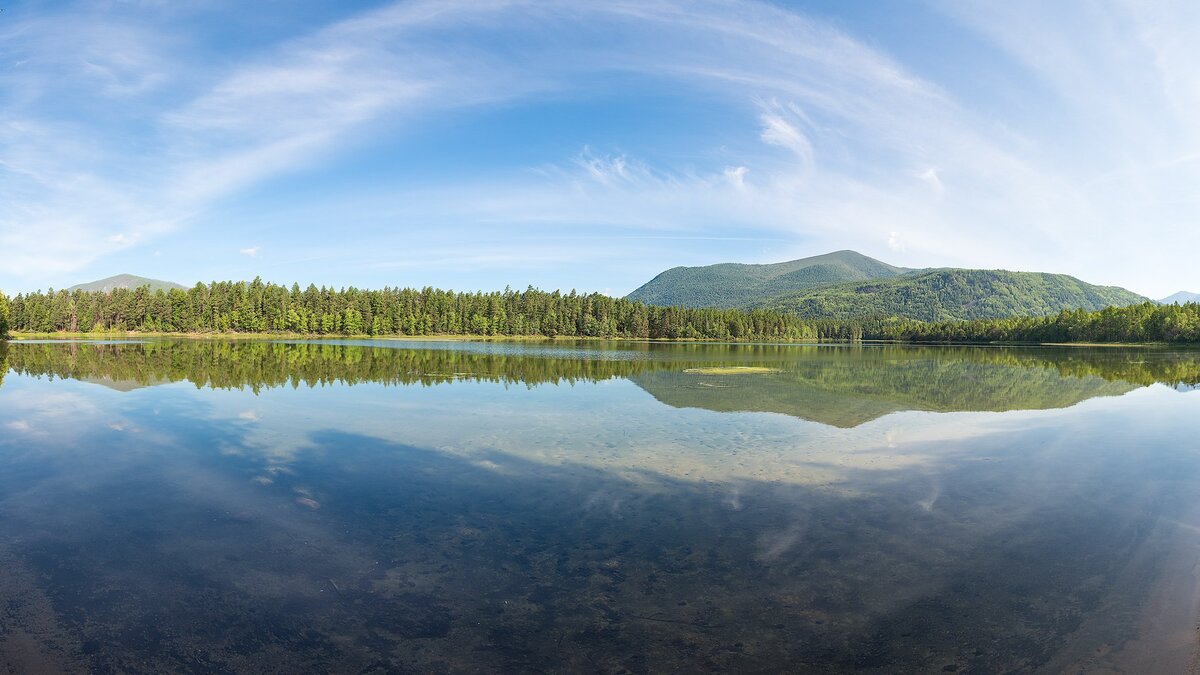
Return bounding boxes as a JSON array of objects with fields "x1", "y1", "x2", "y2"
[{"x1": 629, "y1": 251, "x2": 1148, "y2": 321}]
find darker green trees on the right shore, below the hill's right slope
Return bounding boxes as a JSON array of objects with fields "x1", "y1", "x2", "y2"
[{"x1": 877, "y1": 303, "x2": 1200, "y2": 344}]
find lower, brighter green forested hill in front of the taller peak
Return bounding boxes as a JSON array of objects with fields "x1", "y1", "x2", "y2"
[{"x1": 755, "y1": 269, "x2": 1147, "y2": 321}]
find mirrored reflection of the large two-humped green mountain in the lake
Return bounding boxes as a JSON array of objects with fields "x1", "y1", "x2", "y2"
[{"x1": 631, "y1": 352, "x2": 1139, "y2": 428}]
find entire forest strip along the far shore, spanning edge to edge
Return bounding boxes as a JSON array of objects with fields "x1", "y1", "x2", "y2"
[{"x1": 0, "y1": 279, "x2": 1200, "y2": 344}]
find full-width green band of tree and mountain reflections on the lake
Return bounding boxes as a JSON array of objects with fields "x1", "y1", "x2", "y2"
[{"x1": 0, "y1": 340, "x2": 1200, "y2": 426}]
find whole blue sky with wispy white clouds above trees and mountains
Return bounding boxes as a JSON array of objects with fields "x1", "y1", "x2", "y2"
[{"x1": 0, "y1": 0, "x2": 1200, "y2": 298}]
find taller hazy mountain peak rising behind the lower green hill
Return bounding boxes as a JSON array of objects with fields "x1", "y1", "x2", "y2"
[{"x1": 628, "y1": 251, "x2": 908, "y2": 307}]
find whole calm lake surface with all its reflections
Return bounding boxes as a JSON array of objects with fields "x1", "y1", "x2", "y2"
[{"x1": 0, "y1": 340, "x2": 1200, "y2": 673}]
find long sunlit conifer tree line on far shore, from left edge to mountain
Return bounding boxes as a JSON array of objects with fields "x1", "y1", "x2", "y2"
[{"x1": 0, "y1": 279, "x2": 822, "y2": 340}]
